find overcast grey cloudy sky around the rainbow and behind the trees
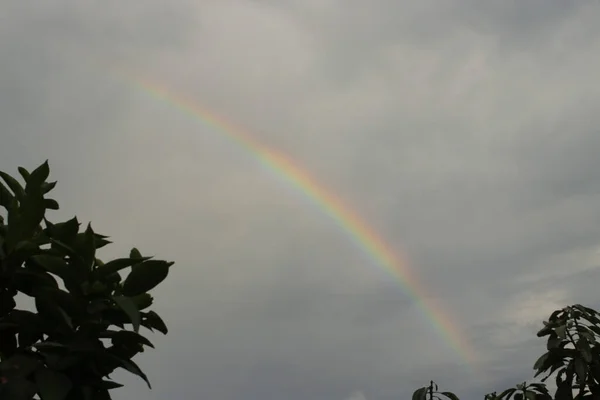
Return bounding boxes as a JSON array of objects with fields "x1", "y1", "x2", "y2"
[{"x1": 0, "y1": 0, "x2": 600, "y2": 400}]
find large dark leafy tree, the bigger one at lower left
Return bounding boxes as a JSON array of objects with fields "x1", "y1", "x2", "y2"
[{"x1": 0, "y1": 161, "x2": 173, "y2": 400}]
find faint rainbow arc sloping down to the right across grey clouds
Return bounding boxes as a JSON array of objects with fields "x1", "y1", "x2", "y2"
[{"x1": 118, "y1": 69, "x2": 476, "y2": 367}]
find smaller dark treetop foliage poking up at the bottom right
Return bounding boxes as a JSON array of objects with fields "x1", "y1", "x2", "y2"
[{"x1": 413, "y1": 304, "x2": 600, "y2": 400}]
